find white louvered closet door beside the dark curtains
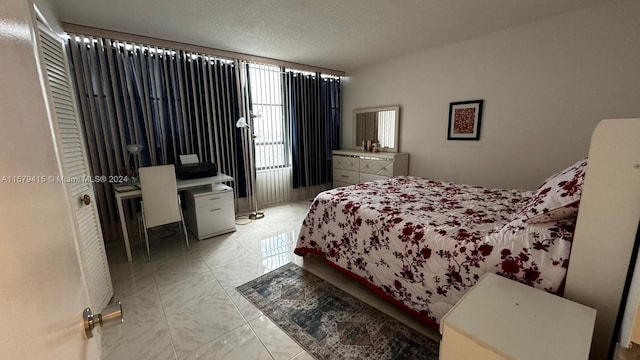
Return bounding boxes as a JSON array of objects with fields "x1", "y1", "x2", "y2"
[{"x1": 38, "y1": 24, "x2": 113, "y2": 312}]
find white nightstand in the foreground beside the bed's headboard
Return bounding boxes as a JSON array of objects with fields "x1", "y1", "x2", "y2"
[{"x1": 440, "y1": 273, "x2": 596, "y2": 360}]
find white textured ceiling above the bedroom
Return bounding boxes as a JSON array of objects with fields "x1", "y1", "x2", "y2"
[{"x1": 50, "y1": 0, "x2": 611, "y2": 72}]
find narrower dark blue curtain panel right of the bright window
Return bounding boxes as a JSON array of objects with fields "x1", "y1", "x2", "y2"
[{"x1": 283, "y1": 71, "x2": 340, "y2": 188}]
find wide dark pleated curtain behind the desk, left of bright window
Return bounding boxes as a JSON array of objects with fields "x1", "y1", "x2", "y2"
[{"x1": 68, "y1": 36, "x2": 246, "y2": 238}]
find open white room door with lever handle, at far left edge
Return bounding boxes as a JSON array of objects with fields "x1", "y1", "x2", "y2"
[{"x1": 0, "y1": 0, "x2": 100, "y2": 360}]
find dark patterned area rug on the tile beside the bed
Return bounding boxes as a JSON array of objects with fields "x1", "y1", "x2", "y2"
[{"x1": 237, "y1": 263, "x2": 439, "y2": 360}]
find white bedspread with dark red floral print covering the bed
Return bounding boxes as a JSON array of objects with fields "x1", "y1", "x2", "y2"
[{"x1": 295, "y1": 176, "x2": 574, "y2": 325}]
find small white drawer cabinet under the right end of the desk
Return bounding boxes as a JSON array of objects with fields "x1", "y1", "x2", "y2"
[{"x1": 185, "y1": 184, "x2": 236, "y2": 240}]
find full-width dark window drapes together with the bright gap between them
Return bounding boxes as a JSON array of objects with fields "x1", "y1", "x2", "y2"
[{"x1": 68, "y1": 34, "x2": 340, "y2": 239}]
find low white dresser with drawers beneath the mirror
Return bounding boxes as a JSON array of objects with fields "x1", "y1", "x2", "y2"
[{"x1": 333, "y1": 150, "x2": 409, "y2": 187}]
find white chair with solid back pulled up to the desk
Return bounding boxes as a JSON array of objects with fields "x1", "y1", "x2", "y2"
[{"x1": 138, "y1": 165, "x2": 189, "y2": 261}]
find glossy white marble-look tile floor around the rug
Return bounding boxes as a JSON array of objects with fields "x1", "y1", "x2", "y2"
[{"x1": 102, "y1": 201, "x2": 439, "y2": 360}]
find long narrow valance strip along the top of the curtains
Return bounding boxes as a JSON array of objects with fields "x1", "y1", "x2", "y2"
[{"x1": 62, "y1": 22, "x2": 345, "y2": 76}]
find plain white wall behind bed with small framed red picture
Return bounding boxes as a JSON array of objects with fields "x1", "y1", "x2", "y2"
[{"x1": 342, "y1": 0, "x2": 640, "y2": 189}]
